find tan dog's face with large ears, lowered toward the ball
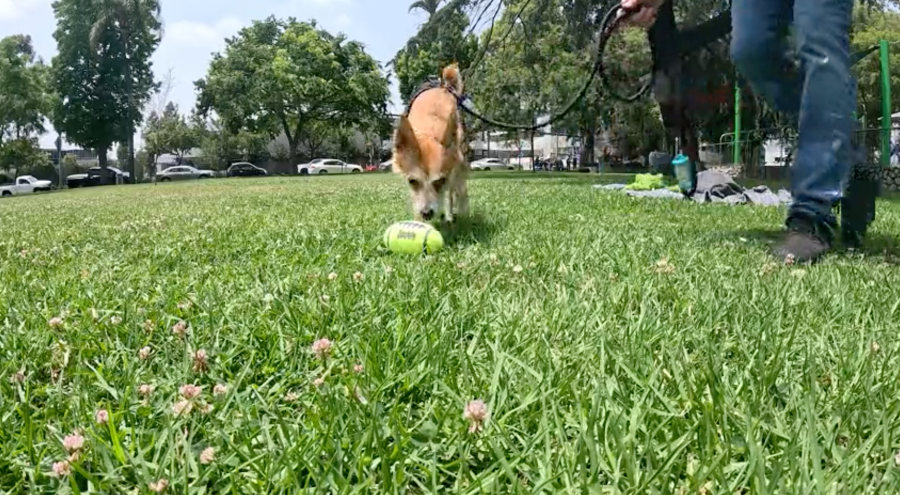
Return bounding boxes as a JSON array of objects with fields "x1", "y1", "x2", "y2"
[{"x1": 394, "y1": 115, "x2": 460, "y2": 220}]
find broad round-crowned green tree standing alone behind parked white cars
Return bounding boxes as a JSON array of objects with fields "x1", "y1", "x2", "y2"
[{"x1": 195, "y1": 17, "x2": 389, "y2": 167}]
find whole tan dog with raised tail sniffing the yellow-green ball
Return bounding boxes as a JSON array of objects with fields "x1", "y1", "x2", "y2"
[{"x1": 393, "y1": 64, "x2": 469, "y2": 222}]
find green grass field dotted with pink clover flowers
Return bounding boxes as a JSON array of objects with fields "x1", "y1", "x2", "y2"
[{"x1": 0, "y1": 174, "x2": 900, "y2": 494}]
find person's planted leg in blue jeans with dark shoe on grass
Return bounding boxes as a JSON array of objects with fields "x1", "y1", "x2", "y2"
[{"x1": 777, "y1": 0, "x2": 856, "y2": 261}]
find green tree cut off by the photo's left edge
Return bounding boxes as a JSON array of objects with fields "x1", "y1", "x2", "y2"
[{"x1": 0, "y1": 35, "x2": 51, "y2": 178}]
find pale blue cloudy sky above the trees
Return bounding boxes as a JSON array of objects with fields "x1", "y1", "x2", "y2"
[{"x1": 0, "y1": 0, "x2": 426, "y2": 148}]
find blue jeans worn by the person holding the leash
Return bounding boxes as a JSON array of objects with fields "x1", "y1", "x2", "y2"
[{"x1": 731, "y1": 0, "x2": 856, "y2": 232}]
